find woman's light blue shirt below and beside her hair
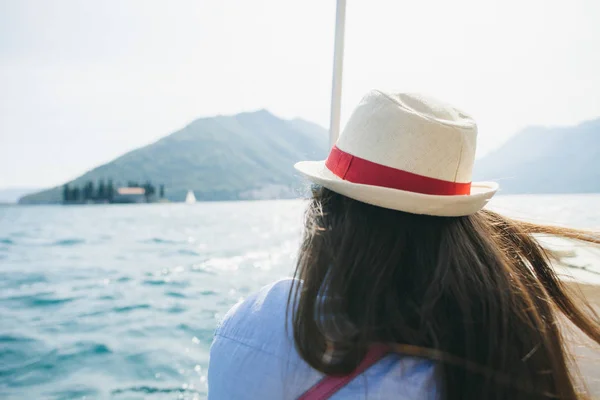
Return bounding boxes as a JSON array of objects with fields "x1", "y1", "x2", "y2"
[{"x1": 208, "y1": 279, "x2": 438, "y2": 400}]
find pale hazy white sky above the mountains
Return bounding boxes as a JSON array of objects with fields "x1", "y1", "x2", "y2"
[{"x1": 0, "y1": 0, "x2": 600, "y2": 187}]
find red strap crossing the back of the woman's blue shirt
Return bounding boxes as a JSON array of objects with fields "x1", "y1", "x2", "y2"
[{"x1": 298, "y1": 344, "x2": 390, "y2": 400}]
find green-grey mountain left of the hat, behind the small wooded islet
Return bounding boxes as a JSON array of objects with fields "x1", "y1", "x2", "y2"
[{"x1": 19, "y1": 110, "x2": 328, "y2": 204}]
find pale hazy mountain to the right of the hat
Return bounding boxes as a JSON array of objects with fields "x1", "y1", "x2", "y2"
[{"x1": 473, "y1": 118, "x2": 600, "y2": 193}]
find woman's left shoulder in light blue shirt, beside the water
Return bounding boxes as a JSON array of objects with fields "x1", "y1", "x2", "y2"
[{"x1": 208, "y1": 279, "x2": 321, "y2": 399}]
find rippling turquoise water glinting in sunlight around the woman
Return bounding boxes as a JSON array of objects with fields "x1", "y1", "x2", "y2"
[{"x1": 0, "y1": 195, "x2": 600, "y2": 399}]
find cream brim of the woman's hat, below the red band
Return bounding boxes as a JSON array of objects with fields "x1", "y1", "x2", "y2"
[{"x1": 294, "y1": 161, "x2": 498, "y2": 217}]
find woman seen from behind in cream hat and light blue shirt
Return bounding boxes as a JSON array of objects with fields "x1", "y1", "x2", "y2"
[{"x1": 209, "y1": 91, "x2": 600, "y2": 400}]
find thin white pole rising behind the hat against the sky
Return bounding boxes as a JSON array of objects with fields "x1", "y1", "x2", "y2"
[{"x1": 329, "y1": 0, "x2": 346, "y2": 146}]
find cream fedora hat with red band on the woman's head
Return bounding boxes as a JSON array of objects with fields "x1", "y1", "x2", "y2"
[{"x1": 295, "y1": 90, "x2": 498, "y2": 216}]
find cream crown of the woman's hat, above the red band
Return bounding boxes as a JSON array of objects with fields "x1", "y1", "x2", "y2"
[{"x1": 336, "y1": 90, "x2": 477, "y2": 183}]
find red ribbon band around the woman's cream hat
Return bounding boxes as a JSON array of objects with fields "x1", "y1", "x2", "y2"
[{"x1": 325, "y1": 146, "x2": 471, "y2": 196}]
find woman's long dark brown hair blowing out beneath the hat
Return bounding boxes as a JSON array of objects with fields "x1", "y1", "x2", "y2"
[{"x1": 288, "y1": 188, "x2": 600, "y2": 400}]
